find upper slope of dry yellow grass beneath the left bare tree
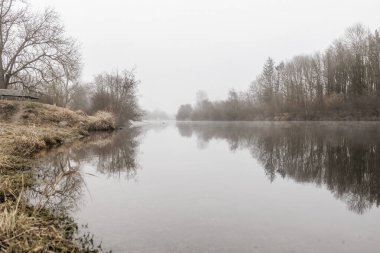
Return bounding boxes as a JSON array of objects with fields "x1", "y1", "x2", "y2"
[{"x1": 0, "y1": 101, "x2": 116, "y2": 169}]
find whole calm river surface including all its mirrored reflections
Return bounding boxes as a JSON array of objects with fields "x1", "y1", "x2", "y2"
[{"x1": 37, "y1": 123, "x2": 380, "y2": 253}]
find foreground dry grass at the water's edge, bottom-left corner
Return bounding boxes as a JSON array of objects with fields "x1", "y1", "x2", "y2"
[{"x1": 0, "y1": 174, "x2": 95, "y2": 252}]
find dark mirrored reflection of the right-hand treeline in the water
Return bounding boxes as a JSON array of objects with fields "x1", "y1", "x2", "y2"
[{"x1": 177, "y1": 122, "x2": 380, "y2": 214}]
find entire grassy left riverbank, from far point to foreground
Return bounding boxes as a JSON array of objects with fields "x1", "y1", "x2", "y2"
[{"x1": 0, "y1": 101, "x2": 116, "y2": 252}]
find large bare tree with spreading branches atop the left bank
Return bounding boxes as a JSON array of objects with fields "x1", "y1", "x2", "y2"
[{"x1": 0, "y1": 0, "x2": 80, "y2": 90}]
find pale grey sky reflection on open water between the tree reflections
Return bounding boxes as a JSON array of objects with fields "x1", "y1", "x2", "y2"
[{"x1": 70, "y1": 122, "x2": 380, "y2": 253}]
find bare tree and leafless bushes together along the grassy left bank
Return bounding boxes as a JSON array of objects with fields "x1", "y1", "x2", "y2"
[{"x1": 0, "y1": 0, "x2": 142, "y2": 122}]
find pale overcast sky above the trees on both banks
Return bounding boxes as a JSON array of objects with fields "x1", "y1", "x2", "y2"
[{"x1": 31, "y1": 0, "x2": 380, "y2": 113}]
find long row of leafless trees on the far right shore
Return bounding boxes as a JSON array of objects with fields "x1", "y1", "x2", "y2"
[{"x1": 177, "y1": 24, "x2": 380, "y2": 121}]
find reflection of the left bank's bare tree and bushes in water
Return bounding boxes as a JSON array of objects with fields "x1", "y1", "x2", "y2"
[{"x1": 28, "y1": 127, "x2": 141, "y2": 211}]
